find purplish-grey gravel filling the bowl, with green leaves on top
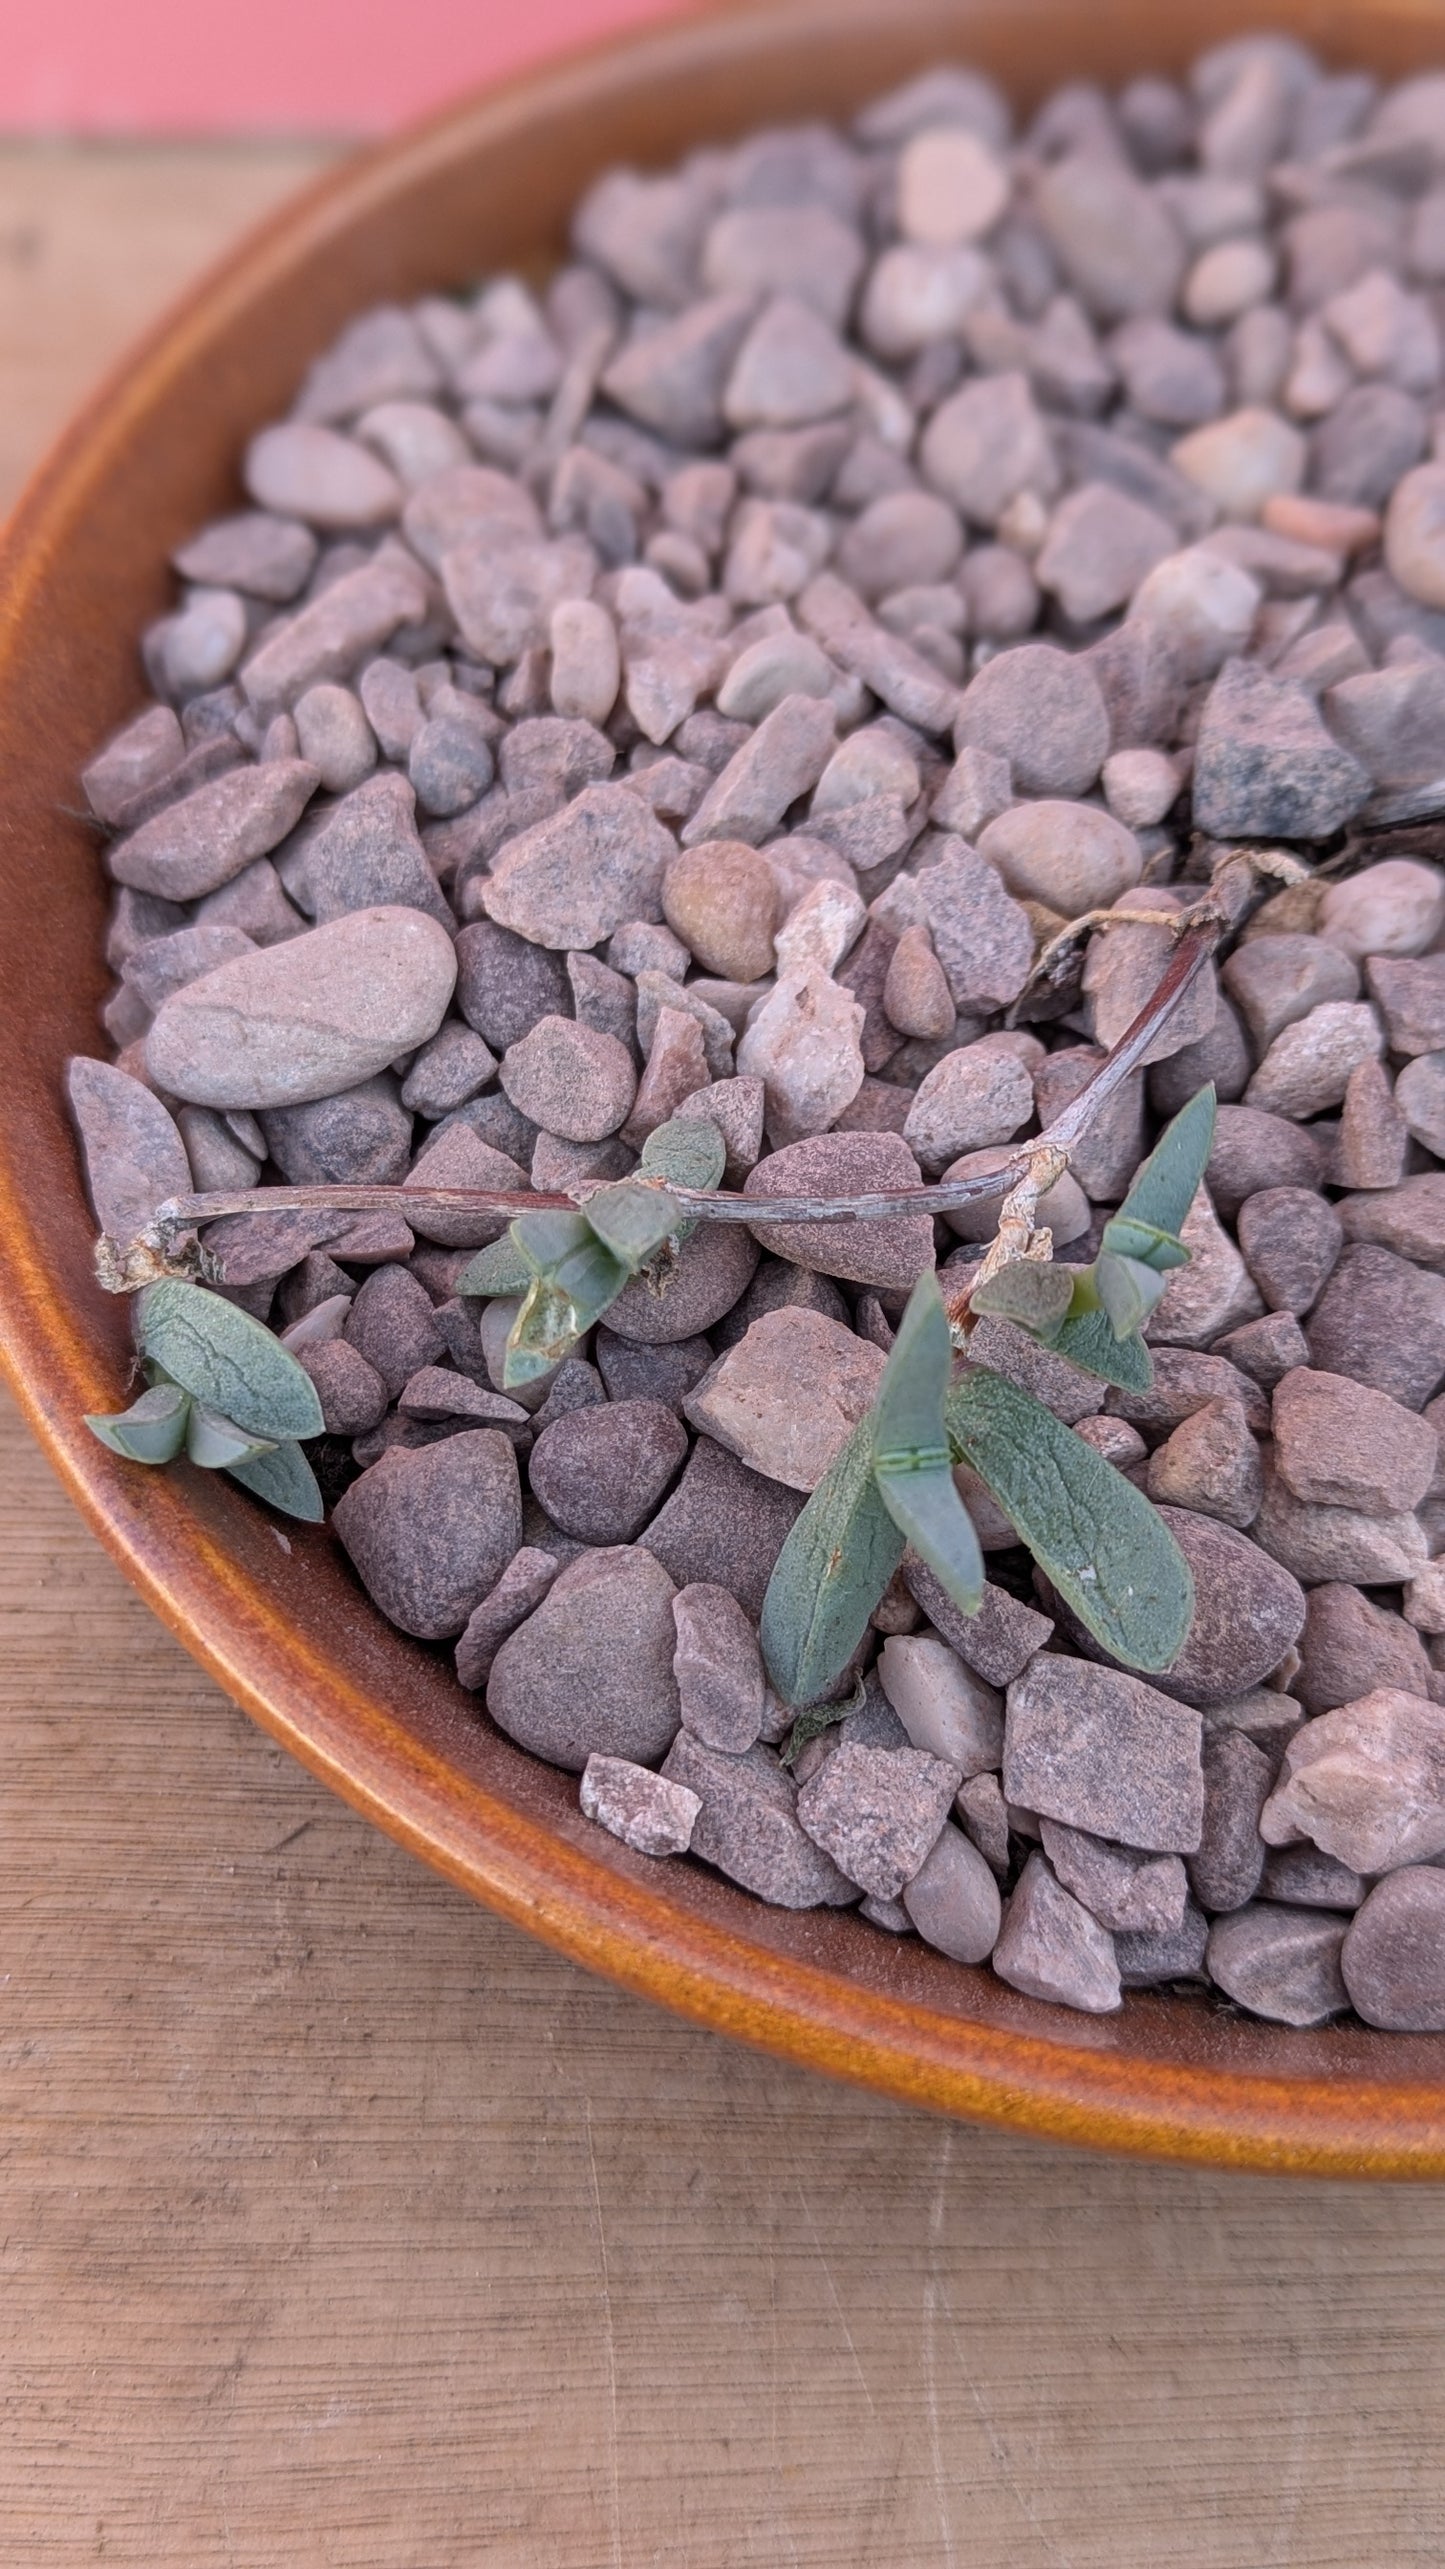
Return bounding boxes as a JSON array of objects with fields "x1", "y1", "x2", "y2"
[{"x1": 69, "y1": 20, "x2": 1445, "y2": 2032}]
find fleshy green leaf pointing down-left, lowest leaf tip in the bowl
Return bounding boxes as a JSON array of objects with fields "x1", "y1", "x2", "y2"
[{"x1": 758, "y1": 1416, "x2": 902, "y2": 1703}]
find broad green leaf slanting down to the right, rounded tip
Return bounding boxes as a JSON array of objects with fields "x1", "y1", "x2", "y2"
[{"x1": 949, "y1": 1367, "x2": 1193, "y2": 1670}]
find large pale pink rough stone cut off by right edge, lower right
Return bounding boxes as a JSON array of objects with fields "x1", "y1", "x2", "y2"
[{"x1": 1260, "y1": 1685, "x2": 1445, "y2": 1873}]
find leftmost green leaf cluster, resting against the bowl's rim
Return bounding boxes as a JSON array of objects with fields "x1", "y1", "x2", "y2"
[{"x1": 85, "y1": 1277, "x2": 324, "y2": 1523}]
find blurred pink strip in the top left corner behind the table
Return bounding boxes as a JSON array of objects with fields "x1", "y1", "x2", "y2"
[{"x1": 0, "y1": 0, "x2": 687, "y2": 134}]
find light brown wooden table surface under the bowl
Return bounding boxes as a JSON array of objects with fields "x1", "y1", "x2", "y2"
[{"x1": 0, "y1": 146, "x2": 1445, "y2": 2569}]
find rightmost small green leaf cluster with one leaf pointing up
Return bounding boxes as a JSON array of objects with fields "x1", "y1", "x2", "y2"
[{"x1": 972, "y1": 1087, "x2": 1214, "y2": 1392}]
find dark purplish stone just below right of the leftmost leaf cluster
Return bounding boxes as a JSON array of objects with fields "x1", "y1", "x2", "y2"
[{"x1": 332, "y1": 1428, "x2": 522, "y2": 1642}]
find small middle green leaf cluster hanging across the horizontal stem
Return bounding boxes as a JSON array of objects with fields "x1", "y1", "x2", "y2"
[{"x1": 458, "y1": 1115, "x2": 728, "y2": 1392}]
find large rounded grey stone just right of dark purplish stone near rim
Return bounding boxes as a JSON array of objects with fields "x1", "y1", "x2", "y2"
[{"x1": 486, "y1": 1531, "x2": 687, "y2": 1783}]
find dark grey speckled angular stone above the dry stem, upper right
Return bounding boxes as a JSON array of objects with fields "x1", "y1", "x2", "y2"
[{"x1": 1193, "y1": 660, "x2": 1370, "y2": 840}]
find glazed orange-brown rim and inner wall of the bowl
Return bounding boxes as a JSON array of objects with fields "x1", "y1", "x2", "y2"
[{"x1": 0, "y1": 0, "x2": 1445, "y2": 2179}]
